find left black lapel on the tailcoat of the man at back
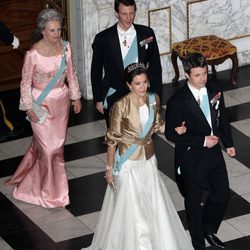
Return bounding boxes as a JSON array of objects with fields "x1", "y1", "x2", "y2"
[{"x1": 108, "y1": 24, "x2": 124, "y2": 74}]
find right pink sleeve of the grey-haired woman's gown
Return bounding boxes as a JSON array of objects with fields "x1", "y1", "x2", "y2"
[{"x1": 67, "y1": 44, "x2": 81, "y2": 100}]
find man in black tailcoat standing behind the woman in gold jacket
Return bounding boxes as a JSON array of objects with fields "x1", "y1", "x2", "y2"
[{"x1": 91, "y1": 0, "x2": 162, "y2": 125}]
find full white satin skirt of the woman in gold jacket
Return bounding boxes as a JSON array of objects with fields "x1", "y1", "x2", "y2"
[{"x1": 83, "y1": 156, "x2": 193, "y2": 250}]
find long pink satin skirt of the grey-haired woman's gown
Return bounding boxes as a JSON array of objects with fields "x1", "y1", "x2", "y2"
[{"x1": 6, "y1": 84, "x2": 70, "y2": 208}]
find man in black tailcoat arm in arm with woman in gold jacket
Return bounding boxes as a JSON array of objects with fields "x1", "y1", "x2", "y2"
[{"x1": 165, "y1": 53, "x2": 235, "y2": 250}]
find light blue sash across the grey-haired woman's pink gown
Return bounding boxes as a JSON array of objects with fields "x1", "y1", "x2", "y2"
[{"x1": 35, "y1": 41, "x2": 68, "y2": 105}]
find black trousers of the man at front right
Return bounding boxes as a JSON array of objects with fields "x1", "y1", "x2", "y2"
[{"x1": 181, "y1": 145, "x2": 230, "y2": 250}]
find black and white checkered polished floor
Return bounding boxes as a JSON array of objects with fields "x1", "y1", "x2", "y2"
[{"x1": 0, "y1": 66, "x2": 250, "y2": 250}]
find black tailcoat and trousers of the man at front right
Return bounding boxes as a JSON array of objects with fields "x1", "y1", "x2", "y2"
[{"x1": 165, "y1": 84, "x2": 233, "y2": 249}]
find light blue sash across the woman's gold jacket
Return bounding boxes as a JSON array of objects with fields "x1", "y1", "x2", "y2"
[{"x1": 113, "y1": 93, "x2": 155, "y2": 175}]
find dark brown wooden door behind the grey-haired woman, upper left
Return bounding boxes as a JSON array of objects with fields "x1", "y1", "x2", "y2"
[{"x1": 0, "y1": 0, "x2": 42, "y2": 92}]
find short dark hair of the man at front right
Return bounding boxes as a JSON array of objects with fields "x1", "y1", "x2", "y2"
[{"x1": 182, "y1": 53, "x2": 207, "y2": 74}]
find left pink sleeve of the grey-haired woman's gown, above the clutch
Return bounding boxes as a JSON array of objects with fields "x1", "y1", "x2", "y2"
[{"x1": 19, "y1": 51, "x2": 35, "y2": 110}]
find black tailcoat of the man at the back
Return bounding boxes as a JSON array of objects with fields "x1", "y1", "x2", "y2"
[{"x1": 91, "y1": 24, "x2": 162, "y2": 119}]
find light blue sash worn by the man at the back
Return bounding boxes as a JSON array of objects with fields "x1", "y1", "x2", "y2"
[{"x1": 103, "y1": 36, "x2": 138, "y2": 109}]
